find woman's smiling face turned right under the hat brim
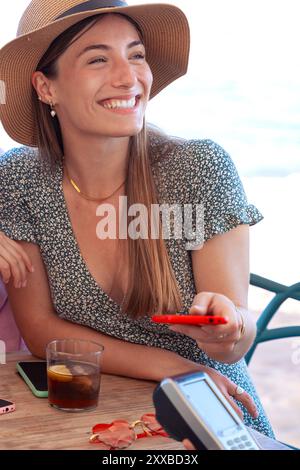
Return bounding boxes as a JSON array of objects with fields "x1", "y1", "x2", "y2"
[{"x1": 37, "y1": 15, "x2": 152, "y2": 141}]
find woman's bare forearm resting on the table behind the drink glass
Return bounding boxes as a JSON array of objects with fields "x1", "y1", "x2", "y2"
[{"x1": 7, "y1": 242, "x2": 205, "y2": 381}]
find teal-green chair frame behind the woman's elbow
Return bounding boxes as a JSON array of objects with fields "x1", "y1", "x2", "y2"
[{"x1": 245, "y1": 274, "x2": 300, "y2": 364}]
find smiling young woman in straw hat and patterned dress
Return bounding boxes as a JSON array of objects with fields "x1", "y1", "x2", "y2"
[{"x1": 0, "y1": 0, "x2": 272, "y2": 436}]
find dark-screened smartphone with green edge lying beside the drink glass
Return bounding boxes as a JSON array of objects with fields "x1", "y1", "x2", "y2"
[{"x1": 16, "y1": 361, "x2": 48, "y2": 398}]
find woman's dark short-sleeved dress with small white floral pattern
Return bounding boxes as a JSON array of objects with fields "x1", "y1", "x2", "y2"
[{"x1": 0, "y1": 135, "x2": 273, "y2": 436}]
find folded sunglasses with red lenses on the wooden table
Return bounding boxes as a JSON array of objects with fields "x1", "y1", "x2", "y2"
[{"x1": 90, "y1": 413, "x2": 169, "y2": 450}]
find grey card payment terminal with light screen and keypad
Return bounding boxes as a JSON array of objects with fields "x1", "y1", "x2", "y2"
[{"x1": 153, "y1": 372, "x2": 260, "y2": 450}]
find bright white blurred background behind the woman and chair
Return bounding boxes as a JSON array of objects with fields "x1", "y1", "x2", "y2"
[{"x1": 0, "y1": 0, "x2": 300, "y2": 447}]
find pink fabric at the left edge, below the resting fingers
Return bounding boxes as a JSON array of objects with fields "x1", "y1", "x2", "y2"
[{"x1": 0, "y1": 279, "x2": 26, "y2": 352}]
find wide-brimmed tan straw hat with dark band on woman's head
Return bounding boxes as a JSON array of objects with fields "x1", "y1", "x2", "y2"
[{"x1": 0, "y1": 0, "x2": 190, "y2": 147}]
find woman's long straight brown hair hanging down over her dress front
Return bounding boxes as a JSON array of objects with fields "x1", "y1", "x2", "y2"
[{"x1": 33, "y1": 15, "x2": 182, "y2": 318}]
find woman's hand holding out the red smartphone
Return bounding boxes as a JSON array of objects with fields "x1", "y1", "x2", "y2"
[{"x1": 170, "y1": 292, "x2": 243, "y2": 355}]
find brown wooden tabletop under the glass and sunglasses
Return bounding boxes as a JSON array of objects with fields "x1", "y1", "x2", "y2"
[{"x1": 0, "y1": 353, "x2": 286, "y2": 450}]
